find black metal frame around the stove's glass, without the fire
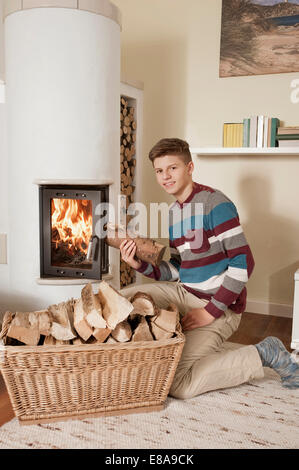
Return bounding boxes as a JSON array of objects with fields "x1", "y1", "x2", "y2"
[{"x1": 39, "y1": 184, "x2": 109, "y2": 280}]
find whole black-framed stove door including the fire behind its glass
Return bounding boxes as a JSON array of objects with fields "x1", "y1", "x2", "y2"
[{"x1": 39, "y1": 184, "x2": 109, "y2": 280}]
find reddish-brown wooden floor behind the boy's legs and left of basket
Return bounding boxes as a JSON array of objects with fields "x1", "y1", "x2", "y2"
[{"x1": 0, "y1": 313, "x2": 292, "y2": 426}]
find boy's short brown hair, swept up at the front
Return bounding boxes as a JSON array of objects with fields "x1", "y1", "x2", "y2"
[{"x1": 148, "y1": 138, "x2": 192, "y2": 163}]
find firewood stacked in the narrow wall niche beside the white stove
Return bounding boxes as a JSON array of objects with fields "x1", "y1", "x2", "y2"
[{"x1": 120, "y1": 96, "x2": 137, "y2": 288}]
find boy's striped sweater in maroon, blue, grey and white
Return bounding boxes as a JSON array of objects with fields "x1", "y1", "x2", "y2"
[{"x1": 138, "y1": 183, "x2": 254, "y2": 318}]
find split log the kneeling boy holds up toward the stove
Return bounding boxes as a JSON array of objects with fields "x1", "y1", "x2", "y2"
[{"x1": 105, "y1": 223, "x2": 166, "y2": 266}]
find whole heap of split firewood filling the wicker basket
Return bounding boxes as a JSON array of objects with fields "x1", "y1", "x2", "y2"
[{"x1": 0, "y1": 281, "x2": 179, "y2": 346}]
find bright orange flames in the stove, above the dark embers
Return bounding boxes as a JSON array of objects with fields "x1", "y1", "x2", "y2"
[{"x1": 51, "y1": 199, "x2": 92, "y2": 254}]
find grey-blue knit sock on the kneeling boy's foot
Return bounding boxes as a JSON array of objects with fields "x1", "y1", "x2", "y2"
[{"x1": 255, "y1": 336, "x2": 299, "y2": 389}]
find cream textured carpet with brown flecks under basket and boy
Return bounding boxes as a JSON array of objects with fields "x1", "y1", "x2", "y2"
[{"x1": 0, "y1": 344, "x2": 299, "y2": 449}]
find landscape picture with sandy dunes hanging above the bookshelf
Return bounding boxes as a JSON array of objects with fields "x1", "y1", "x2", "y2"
[{"x1": 219, "y1": 0, "x2": 299, "y2": 77}]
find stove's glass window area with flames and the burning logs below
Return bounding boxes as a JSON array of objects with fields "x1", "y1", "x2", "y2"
[{"x1": 51, "y1": 199, "x2": 92, "y2": 269}]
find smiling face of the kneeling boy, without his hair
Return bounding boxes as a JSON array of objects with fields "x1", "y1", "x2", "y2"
[{"x1": 154, "y1": 155, "x2": 194, "y2": 196}]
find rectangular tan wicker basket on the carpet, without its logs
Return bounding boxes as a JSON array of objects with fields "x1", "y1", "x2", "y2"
[{"x1": 0, "y1": 325, "x2": 185, "y2": 424}]
